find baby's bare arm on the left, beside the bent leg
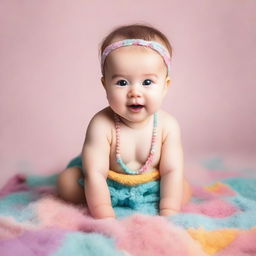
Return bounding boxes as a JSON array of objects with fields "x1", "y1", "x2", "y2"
[{"x1": 82, "y1": 113, "x2": 115, "y2": 218}]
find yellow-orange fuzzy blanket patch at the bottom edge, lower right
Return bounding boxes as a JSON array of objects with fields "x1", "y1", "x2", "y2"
[{"x1": 188, "y1": 228, "x2": 239, "y2": 255}]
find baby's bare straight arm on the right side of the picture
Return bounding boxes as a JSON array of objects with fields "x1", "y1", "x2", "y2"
[{"x1": 159, "y1": 118, "x2": 183, "y2": 216}]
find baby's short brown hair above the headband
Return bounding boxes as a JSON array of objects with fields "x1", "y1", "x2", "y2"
[{"x1": 100, "y1": 24, "x2": 172, "y2": 57}]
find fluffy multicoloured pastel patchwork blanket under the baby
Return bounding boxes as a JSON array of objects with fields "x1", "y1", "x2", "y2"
[{"x1": 0, "y1": 158, "x2": 256, "y2": 256}]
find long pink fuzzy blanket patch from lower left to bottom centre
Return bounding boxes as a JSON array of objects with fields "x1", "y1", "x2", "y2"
[{"x1": 33, "y1": 197, "x2": 208, "y2": 256}]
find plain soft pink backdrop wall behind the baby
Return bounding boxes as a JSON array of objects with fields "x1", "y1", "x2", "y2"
[{"x1": 0, "y1": 0, "x2": 256, "y2": 184}]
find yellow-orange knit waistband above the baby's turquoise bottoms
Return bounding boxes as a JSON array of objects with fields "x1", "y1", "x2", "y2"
[{"x1": 108, "y1": 170, "x2": 160, "y2": 186}]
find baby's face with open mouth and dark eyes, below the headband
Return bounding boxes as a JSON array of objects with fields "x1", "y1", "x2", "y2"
[{"x1": 102, "y1": 42, "x2": 170, "y2": 122}]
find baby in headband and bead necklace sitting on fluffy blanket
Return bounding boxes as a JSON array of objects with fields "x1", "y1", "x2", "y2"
[{"x1": 58, "y1": 24, "x2": 190, "y2": 218}]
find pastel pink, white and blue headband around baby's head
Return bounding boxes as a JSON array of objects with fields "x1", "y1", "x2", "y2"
[{"x1": 101, "y1": 39, "x2": 171, "y2": 74}]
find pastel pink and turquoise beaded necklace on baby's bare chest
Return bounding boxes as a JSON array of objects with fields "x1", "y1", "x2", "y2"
[{"x1": 115, "y1": 113, "x2": 157, "y2": 174}]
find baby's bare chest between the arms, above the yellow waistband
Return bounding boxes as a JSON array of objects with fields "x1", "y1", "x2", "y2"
[{"x1": 106, "y1": 109, "x2": 166, "y2": 173}]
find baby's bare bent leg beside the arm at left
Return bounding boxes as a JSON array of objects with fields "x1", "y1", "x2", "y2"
[{"x1": 57, "y1": 166, "x2": 86, "y2": 204}]
